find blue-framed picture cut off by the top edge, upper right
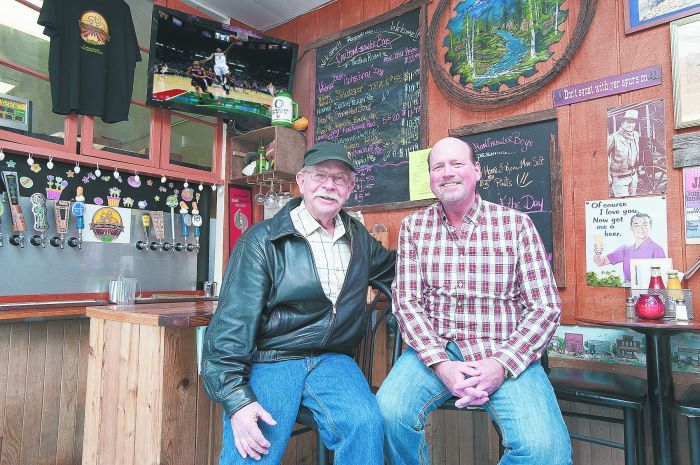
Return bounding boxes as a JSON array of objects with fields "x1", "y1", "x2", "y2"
[{"x1": 624, "y1": 0, "x2": 700, "y2": 34}]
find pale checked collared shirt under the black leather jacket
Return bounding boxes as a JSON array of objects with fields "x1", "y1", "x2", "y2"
[{"x1": 289, "y1": 201, "x2": 350, "y2": 305}]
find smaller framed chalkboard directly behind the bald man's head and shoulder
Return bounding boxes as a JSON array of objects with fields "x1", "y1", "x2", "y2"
[{"x1": 450, "y1": 112, "x2": 564, "y2": 286}]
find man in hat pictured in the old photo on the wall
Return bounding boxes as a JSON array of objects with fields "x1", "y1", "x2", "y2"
[{"x1": 608, "y1": 110, "x2": 639, "y2": 197}]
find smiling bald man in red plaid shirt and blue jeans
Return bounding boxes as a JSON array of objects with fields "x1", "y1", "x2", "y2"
[{"x1": 377, "y1": 138, "x2": 571, "y2": 465}]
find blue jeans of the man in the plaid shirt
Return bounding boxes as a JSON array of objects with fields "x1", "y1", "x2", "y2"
[{"x1": 377, "y1": 342, "x2": 572, "y2": 465}]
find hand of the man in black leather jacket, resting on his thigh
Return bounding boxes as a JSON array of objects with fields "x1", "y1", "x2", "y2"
[{"x1": 231, "y1": 402, "x2": 277, "y2": 460}]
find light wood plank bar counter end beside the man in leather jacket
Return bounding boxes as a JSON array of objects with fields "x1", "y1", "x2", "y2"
[{"x1": 82, "y1": 302, "x2": 221, "y2": 465}]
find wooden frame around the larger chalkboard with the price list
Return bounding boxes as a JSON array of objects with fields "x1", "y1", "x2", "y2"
[{"x1": 302, "y1": 0, "x2": 435, "y2": 212}]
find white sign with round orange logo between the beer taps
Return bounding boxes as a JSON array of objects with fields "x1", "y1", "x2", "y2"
[{"x1": 85, "y1": 204, "x2": 131, "y2": 244}]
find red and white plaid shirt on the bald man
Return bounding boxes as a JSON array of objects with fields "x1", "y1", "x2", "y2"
[{"x1": 393, "y1": 194, "x2": 561, "y2": 376}]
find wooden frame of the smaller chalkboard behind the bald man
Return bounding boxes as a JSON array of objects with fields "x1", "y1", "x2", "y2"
[{"x1": 448, "y1": 109, "x2": 566, "y2": 288}]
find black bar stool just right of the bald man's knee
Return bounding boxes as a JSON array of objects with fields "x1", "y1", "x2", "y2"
[{"x1": 542, "y1": 362, "x2": 647, "y2": 465}]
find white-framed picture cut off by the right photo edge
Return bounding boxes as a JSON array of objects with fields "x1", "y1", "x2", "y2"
[{"x1": 671, "y1": 15, "x2": 700, "y2": 129}]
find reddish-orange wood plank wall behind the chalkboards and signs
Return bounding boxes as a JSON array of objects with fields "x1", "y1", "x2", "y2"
[{"x1": 268, "y1": 0, "x2": 700, "y2": 324}]
